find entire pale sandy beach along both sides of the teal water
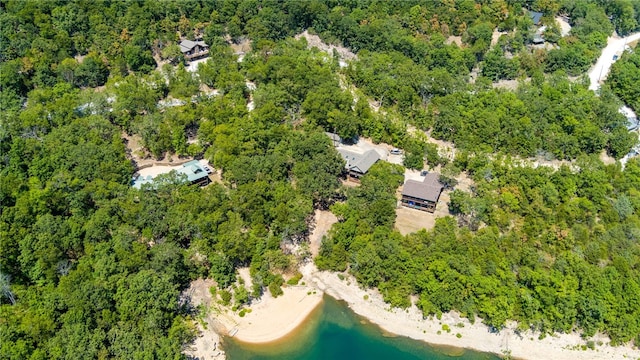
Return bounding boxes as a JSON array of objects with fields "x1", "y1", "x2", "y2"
[{"x1": 189, "y1": 214, "x2": 640, "y2": 360}]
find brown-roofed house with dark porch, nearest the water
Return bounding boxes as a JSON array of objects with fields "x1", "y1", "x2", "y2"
[{"x1": 401, "y1": 173, "x2": 443, "y2": 213}]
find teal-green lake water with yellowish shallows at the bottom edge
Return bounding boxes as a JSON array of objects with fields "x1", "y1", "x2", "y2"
[{"x1": 224, "y1": 296, "x2": 499, "y2": 360}]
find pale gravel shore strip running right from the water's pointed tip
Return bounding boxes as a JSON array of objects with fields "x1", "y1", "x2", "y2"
[{"x1": 301, "y1": 263, "x2": 640, "y2": 360}]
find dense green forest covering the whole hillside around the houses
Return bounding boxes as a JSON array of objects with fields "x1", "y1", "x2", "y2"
[{"x1": 0, "y1": 0, "x2": 640, "y2": 359}]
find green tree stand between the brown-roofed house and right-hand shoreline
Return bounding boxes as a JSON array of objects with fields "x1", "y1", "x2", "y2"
[{"x1": 316, "y1": 158, "x2": 640, "y2": 344}]
